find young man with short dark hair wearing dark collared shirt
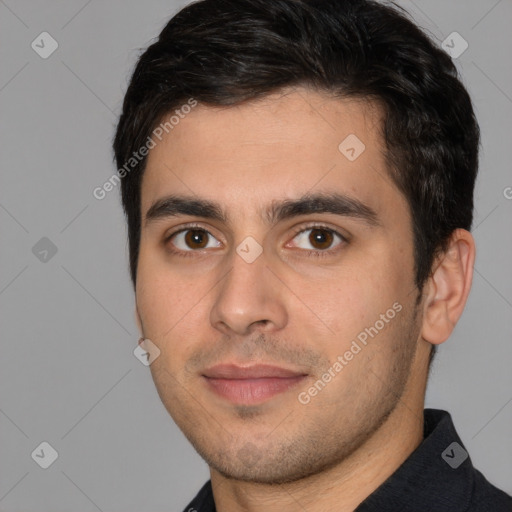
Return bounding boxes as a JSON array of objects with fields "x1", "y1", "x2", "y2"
[{"x1": 114, "y1": 0, "x2": 512, "y2": 512}]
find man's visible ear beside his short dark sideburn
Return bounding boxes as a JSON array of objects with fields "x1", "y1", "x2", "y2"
[{"x1": 421, "y1": 229, "x2": 476, "y2": 345}]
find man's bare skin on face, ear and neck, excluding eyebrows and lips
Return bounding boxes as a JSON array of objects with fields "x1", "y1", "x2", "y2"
[{"x1": 136, "y1": 88, "x2": 475, "y2": 512}]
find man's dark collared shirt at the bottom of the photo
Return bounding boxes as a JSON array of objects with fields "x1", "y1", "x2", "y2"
[{"x1": 184, "y1": 409, "x2": 512, "y2": 512}]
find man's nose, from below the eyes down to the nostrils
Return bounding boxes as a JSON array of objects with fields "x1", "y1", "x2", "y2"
[{"x1": 210, "y1": 247, "x2": 288, "y2": 336}]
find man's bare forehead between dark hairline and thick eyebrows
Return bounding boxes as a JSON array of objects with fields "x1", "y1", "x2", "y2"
[{"x1": 141, "y1": 88, "x2": 404, "y2": 222}]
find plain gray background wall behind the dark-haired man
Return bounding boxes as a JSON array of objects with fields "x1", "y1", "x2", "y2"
[{"x1": 0, "y1": 0, "x2": 512, "y2": 512}]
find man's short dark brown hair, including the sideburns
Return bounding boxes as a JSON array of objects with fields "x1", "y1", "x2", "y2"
[{"x1": 113, "y1": 0, "x2": 480, "y2": 302}]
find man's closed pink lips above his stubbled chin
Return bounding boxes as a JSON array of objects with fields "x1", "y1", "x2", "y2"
[{"x1": 202, "y1": 364, "x2": 307, "y2": 405}]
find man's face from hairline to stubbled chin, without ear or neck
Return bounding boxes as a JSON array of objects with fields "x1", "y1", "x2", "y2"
[{"x1": 136, "y1": 89, "x2": 421, "y2": 483}]
